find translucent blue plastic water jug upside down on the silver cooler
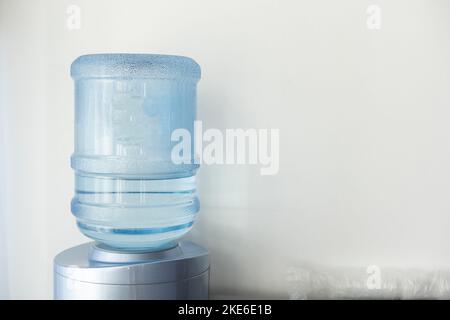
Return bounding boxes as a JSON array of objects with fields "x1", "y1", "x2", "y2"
[{"x1": 71, "y1": 54, "x2": 200, "y2": 251}]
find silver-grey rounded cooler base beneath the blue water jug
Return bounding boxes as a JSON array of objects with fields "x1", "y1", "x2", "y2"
[{"x1": 54, "y1": 241, "x2": 209, "y2": 300}]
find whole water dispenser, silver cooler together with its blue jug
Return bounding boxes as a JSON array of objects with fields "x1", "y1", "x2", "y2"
[{"x1": 54, "y1": 54, "x2": 209, "y2": 299}]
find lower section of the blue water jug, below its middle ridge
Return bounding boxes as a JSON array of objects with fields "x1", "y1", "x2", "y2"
[{"x1": 72, "y1": 173, "x2": 199, "y2": 251}]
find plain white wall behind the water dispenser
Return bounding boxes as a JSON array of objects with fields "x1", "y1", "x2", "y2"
[{"x1": 0, "y1": 0, "x2": 450, "y2": 298}]
